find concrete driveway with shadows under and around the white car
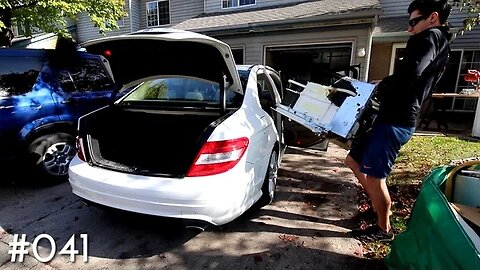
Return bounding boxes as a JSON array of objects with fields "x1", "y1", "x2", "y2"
[{"x1": 0, "y1": 144, "x2": 382, "y2": 270}]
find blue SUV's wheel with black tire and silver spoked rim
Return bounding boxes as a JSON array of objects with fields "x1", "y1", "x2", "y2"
[{"x1": 28, "y1": 133, "x2": 76, "y2": 182}]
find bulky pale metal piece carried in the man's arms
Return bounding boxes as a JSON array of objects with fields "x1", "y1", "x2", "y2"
[{"x1": 276, "y1": 77, "x2": 375, "y2": 146}]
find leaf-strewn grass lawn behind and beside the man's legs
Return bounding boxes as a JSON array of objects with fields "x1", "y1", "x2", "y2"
[{"x1": 364, "y1": 136, "x2": 480, "y2": 259}]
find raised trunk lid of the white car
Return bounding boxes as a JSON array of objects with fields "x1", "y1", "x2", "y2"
[{"x1": 80, "y1": 28, "x2": 243, "y2": 102}]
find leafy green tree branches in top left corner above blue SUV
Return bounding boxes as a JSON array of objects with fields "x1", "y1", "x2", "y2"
[{"x1": 0, "y1": 0, "x2": 127, "y2": 47}]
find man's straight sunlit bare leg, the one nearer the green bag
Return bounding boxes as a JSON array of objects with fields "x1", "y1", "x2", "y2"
[{"x1": 366, "y1": 175, "x2": 392, "y2": 233}]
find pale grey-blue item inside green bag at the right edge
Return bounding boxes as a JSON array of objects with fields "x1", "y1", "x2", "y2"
[{"x1": 452, "y1": 171, "x2": 480, "y2": 207}]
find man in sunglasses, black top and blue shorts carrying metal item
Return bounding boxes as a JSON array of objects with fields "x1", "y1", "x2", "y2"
[{"x1": 345, "y1": 0, "x2": 451, "y2": 241}]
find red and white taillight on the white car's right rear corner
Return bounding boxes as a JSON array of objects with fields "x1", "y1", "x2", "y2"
[{"x1": 187, "y1": 137, "x2": 248, "y2": 176}]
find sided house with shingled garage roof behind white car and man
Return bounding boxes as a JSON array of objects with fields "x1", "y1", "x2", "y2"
[{"x1": 77, "y1": 0, "x2": 480, "y2": 113}]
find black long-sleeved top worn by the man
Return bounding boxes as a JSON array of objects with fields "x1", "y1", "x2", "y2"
[{"x1": 377, "y1": 26, "x2": 451, "y2": 127}]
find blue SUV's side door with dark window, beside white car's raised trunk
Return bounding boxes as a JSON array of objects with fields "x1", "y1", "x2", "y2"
[{"x1": 53, "y1": 54, "x2": 114, "y2": 121}]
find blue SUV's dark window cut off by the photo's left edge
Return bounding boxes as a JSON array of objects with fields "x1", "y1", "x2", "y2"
[{"x1": 0, "y1": 56, "x2": 44, "y2": 97}]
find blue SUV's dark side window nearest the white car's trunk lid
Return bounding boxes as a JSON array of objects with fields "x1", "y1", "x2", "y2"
[{"x1": 58, "y1": 58, "x2": 113, "y2": 92}]
